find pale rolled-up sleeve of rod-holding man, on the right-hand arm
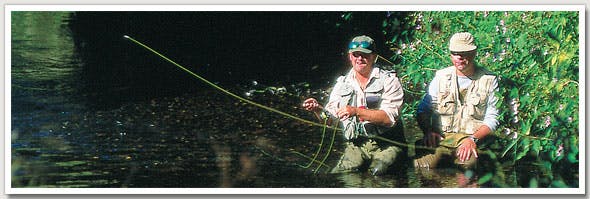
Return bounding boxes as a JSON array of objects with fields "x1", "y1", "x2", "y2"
[{"x1": 379, "y1": 73, "x2": 404, "y2": 126}]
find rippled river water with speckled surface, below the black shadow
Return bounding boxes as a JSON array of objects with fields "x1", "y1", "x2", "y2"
[{"x1": 11, "y1": 12, "x2": 532, "y2": 188}]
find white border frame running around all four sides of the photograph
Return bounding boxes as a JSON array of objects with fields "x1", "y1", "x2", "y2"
[{"x1": 4, "y1": 5, "x2": 586, "y2": 195}]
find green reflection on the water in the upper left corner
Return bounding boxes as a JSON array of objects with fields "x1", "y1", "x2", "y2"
[{"x1": 11, "y1": 12, "x2": 81, "y2": 92}]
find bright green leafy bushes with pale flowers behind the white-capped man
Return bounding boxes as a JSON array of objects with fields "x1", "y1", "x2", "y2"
[{"x1": 383, "y1": 11, "x2": 580, "y2": 187}]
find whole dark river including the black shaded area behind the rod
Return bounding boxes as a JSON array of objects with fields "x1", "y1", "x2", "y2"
[{"x1": 11, "y1": 12, "x2": 532, "y2": 188}]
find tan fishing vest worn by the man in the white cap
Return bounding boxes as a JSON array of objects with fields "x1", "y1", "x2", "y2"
[{"x1": 435, "y1": 66, "x2": 496, "y2": 134}]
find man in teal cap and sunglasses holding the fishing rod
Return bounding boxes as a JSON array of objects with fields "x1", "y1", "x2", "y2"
[{"x1": 303, "y1": 35, "x2": 406, "y2": 175}]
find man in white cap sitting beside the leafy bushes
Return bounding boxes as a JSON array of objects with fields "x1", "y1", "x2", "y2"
[{"x1": 414, "y1": 32, "x2": 498, "y2": 169}]
